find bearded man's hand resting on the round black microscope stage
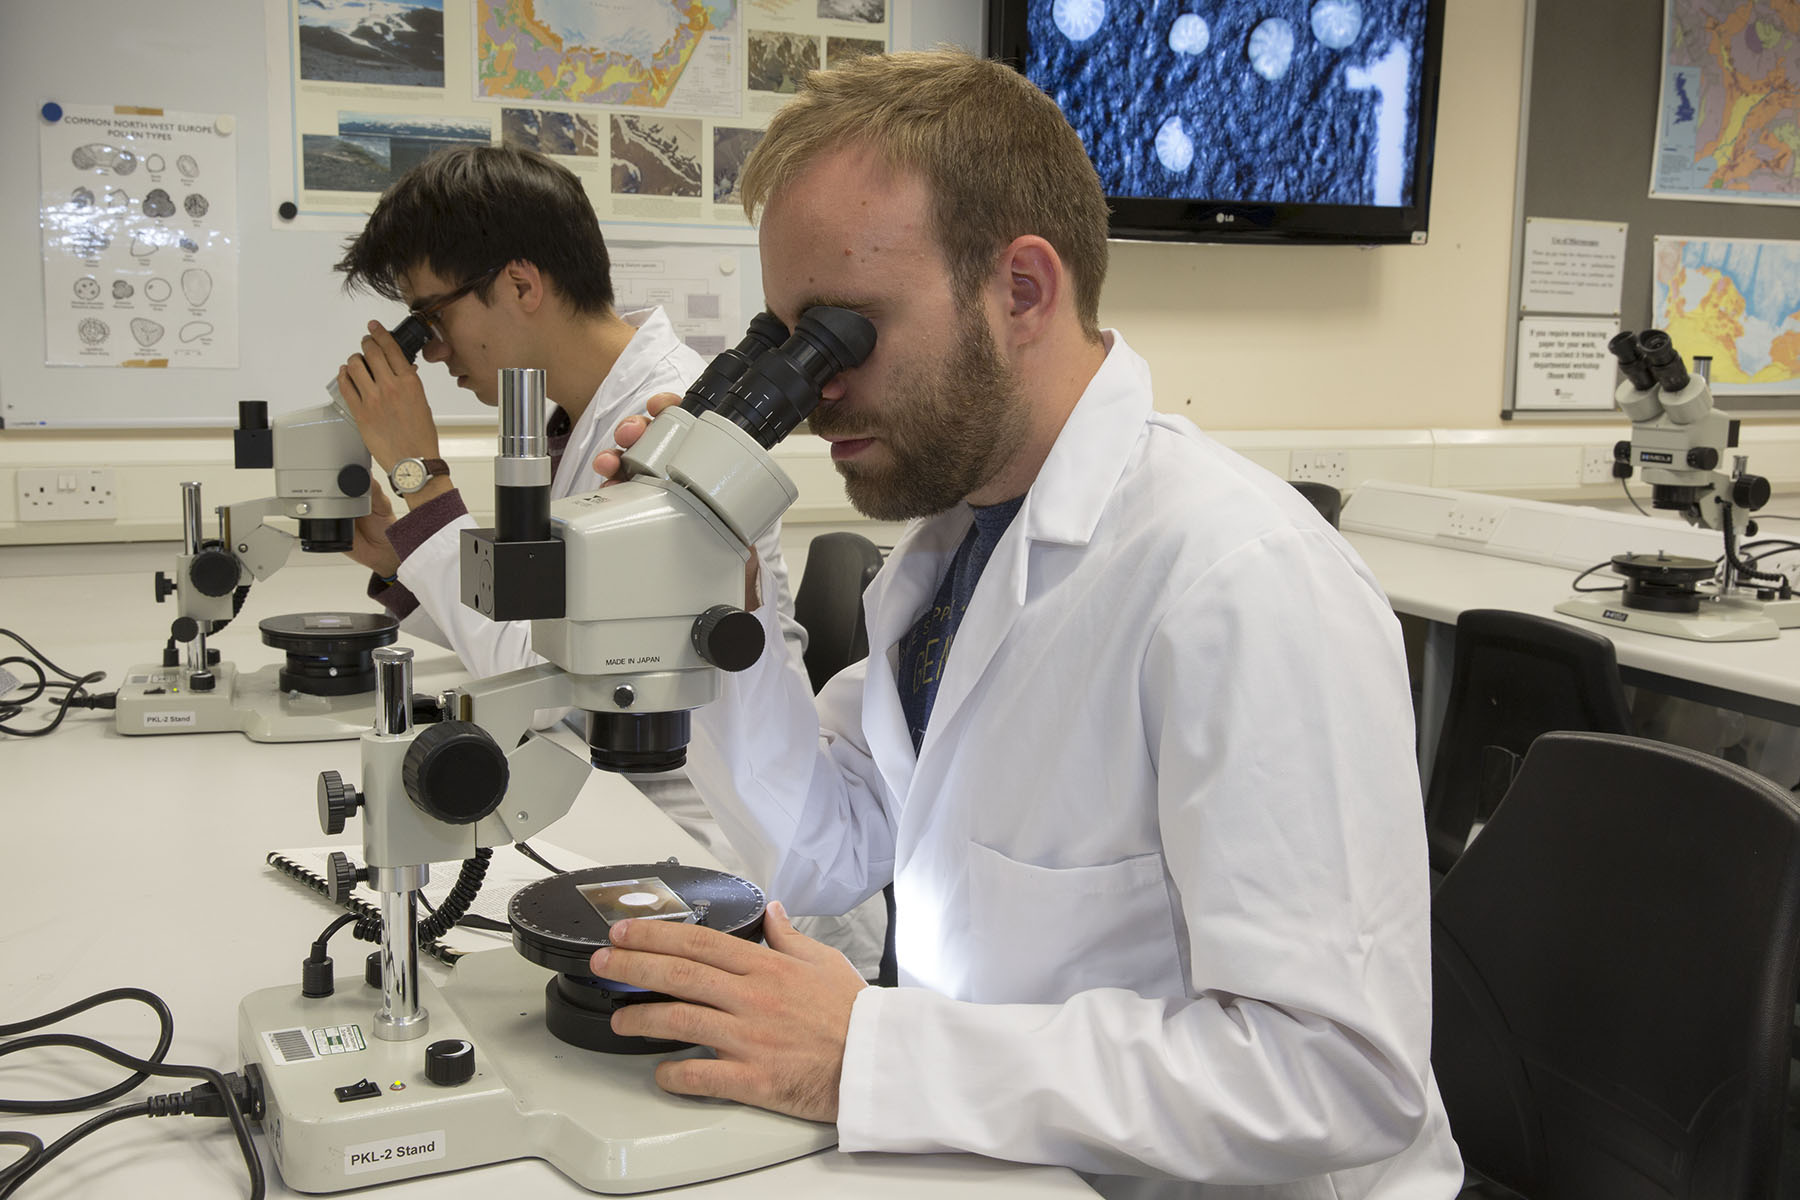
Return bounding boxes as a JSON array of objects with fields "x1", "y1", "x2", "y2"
[{"x1": 592, "y1": 903, "x2": 868, "y2": 1121}]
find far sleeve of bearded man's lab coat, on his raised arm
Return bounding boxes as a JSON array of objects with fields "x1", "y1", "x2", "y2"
[{"x1": 688, "y1": 570, "x2": 893, "y2": 916}]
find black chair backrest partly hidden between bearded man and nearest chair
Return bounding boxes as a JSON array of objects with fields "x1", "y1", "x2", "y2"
[{"x1": 1426, "y1": 608, "x2": 1633, "y2": 873}]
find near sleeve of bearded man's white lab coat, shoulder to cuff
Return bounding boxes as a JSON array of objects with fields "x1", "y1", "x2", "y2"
[{"x1": 839, "y1": 529, "x2": 1431, "y2": 1195}]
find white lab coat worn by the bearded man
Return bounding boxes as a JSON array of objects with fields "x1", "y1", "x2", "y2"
[{"x1": 689, "y1": 331, "x2": 1462, "y2": 1200}]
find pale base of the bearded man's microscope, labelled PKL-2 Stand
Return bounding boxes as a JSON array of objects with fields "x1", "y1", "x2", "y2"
[{"x1": 238, "y1": 948, "x2": 837, "y2": 1193}]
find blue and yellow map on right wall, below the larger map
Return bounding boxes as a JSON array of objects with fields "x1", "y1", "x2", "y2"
[{"x1": 1652, "y1": 237, "x2": 1800, "y2": 394}]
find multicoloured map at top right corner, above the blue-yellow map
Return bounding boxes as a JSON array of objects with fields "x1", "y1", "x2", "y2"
[{"x1": 1651, "y1": 0, "x2": 1800, "y2": 203}]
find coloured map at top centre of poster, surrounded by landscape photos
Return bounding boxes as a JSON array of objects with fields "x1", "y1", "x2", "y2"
[{"x1": 475, "y1": 0, "x2": 738, "y2": 108}]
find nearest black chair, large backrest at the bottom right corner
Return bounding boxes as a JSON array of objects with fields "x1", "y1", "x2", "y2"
[{"x1": 1431, "y1": 732, "x2": 1800, "y2": 1200}]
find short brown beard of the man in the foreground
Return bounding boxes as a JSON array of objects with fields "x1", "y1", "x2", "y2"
[{"x1": 810, "y1": 306, "x2": 1028, "y2": 520}]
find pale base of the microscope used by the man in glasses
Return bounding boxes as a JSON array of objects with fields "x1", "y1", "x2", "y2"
[{"x1": 113, "y1": 662, "x2": 374, "y2": 741}]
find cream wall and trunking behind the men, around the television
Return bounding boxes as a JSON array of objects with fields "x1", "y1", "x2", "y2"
[{"x1": 0, "y1": 0, "x2": 1800, "y2": 545}]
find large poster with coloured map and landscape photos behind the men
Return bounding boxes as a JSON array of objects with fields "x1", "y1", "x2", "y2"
[{"x1": 268, "y1": 0, "x2": 895, "y2": 243}]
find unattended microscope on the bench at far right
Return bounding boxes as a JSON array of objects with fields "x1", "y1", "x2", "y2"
[{"x1": 1555, "y1": 329, "x2": 1800, "y2": 642}]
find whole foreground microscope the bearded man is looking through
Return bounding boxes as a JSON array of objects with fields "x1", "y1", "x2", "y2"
[{"x1": 238, "y1": 308, "x2": 875, "y2": 1193}]
